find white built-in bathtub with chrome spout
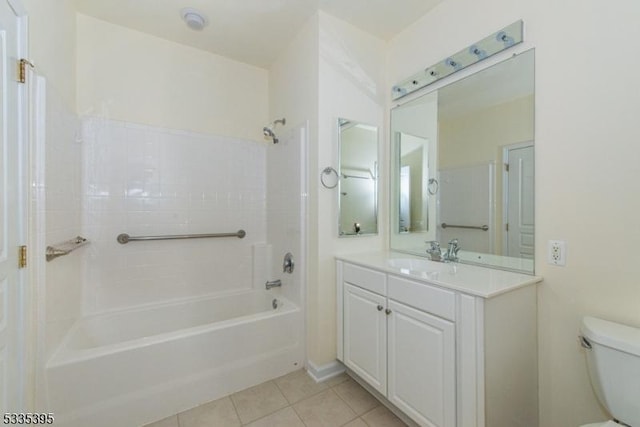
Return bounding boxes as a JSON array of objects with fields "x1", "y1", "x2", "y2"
[{"x1": 46, "y1": 291, "x2": 304, "y2": 427}]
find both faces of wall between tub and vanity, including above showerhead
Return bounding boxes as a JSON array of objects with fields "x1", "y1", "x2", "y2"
[{"x1": 269, "y1": 13, "x2": 387, "y2": 366}]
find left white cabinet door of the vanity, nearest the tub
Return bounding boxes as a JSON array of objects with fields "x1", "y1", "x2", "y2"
[{"x1": 344, "y1": 283, "x2": 387, "y2": 394}]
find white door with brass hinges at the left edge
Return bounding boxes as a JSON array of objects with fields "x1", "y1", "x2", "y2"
[{"x1": 0, "y1": 0, "x2": 24, "y2": 413}]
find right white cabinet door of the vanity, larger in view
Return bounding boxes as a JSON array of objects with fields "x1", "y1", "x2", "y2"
[{"x1": 387, "y1": 300, "x2": 456, "y2": 427}]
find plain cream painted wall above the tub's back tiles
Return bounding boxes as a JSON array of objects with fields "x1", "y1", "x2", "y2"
[{"x1": 77, "y1": 14, "x2": 268, "y2": 141}]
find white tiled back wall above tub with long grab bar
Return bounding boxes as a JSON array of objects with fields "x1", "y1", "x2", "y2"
[{"x1": 82, "y1": 118, "x2": 267, "y2": 313}]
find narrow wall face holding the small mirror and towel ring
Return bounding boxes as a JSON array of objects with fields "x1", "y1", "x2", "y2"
[{"x1": 316, "y1": 12, "x2": 388, "y2": 366}]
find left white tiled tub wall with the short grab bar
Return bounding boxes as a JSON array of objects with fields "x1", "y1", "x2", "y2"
[{"x1": 32, "y1": 77, "x2": 82, "y2": 354}]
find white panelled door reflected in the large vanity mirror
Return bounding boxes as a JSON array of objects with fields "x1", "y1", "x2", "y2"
[{"x1": 504, "y1": 145, "x2": 534, "y2": 259}]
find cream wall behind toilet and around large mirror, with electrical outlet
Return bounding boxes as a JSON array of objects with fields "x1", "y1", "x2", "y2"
[{"x1": 388, "y1": 0, "x2": 640, "y2": 427}]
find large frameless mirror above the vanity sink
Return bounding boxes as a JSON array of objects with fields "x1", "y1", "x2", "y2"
[{"x1": 390, "y1": 49, "x2": 534, "y2": 273}]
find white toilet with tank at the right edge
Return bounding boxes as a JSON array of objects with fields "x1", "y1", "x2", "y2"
[{"x1": 580, "y1": 317, "x2": 640, "y2": 427}]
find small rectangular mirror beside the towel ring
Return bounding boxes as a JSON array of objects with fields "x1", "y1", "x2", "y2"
[{"x1": 338, "y1": 119, "x2": 378, "y2": 237}]
